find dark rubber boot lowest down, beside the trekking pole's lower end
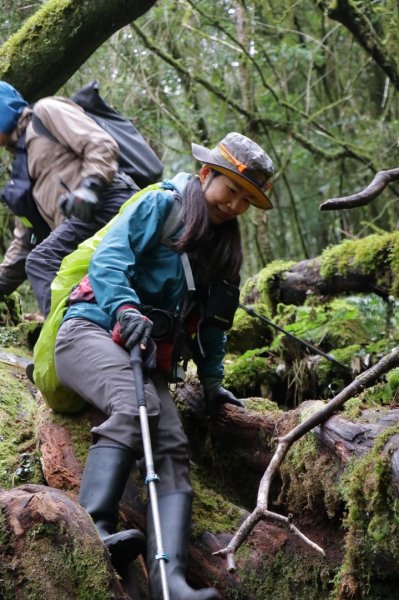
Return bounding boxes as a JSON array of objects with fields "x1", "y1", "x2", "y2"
[{"x1": 147, "y1": 492, "x2": 221, "y2": 600}]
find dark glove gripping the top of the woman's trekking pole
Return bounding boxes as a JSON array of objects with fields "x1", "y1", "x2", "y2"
[{"x1": 112, "y1": 307, "x2": 153, "y2": 350}]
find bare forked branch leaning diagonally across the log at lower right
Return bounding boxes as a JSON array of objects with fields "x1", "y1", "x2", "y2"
[{"x1": 214, "y1": 348, "x2": 399, "y2": 573}]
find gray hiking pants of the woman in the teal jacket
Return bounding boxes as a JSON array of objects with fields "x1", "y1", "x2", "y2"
[{"x1": 55, "y1": 318, "x2": 191, "y2": 495}]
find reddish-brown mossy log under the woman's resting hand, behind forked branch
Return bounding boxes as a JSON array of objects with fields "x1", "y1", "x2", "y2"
[{"x1": 177, "y1": 378, "x2": 399, "y2": 510}]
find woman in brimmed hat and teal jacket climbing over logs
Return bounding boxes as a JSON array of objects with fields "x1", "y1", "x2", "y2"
[{"x1": 55, "y1": 132, "x2": 273, "y2": 600}]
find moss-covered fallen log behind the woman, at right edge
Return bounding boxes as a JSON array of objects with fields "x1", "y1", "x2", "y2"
[{"x1": 242, "y1": 231, "x2": 399, "y2": 313}]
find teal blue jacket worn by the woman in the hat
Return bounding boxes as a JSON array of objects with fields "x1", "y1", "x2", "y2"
[{"x1": 65, "y1": 173, "x2": 226, "y2": 381}]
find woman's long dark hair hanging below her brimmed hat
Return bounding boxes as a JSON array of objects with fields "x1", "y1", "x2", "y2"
[{"x1": 175, "y1": 171, "x2": 243, "y2": 284}]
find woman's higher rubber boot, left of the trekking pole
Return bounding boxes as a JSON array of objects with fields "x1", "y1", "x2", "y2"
[{"x1": 79, "y1": 442, "x2": 145, "y2": 568}]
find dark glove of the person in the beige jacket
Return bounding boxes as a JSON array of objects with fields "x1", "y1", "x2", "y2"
[{"x1": 59, "y1": 177, "x2": 104, "y2": 223}]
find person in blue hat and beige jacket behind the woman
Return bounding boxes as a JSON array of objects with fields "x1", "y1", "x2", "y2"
[{"x1": 0, "y1": 81, "x2": 139, "y2": 316}]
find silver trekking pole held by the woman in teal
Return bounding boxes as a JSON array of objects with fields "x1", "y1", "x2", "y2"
[{"x1": 130, "y1": 344, "x2": 170, "y2": 600}]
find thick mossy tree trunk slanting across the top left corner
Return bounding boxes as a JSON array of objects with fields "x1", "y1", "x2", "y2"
[{"x1": 0, "y1": 0, "x2": 156, "y2": 102}]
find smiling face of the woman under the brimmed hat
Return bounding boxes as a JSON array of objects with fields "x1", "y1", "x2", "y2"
[{"x1": 199, "y1": 165, "x2": 252, "y2": 225}]
